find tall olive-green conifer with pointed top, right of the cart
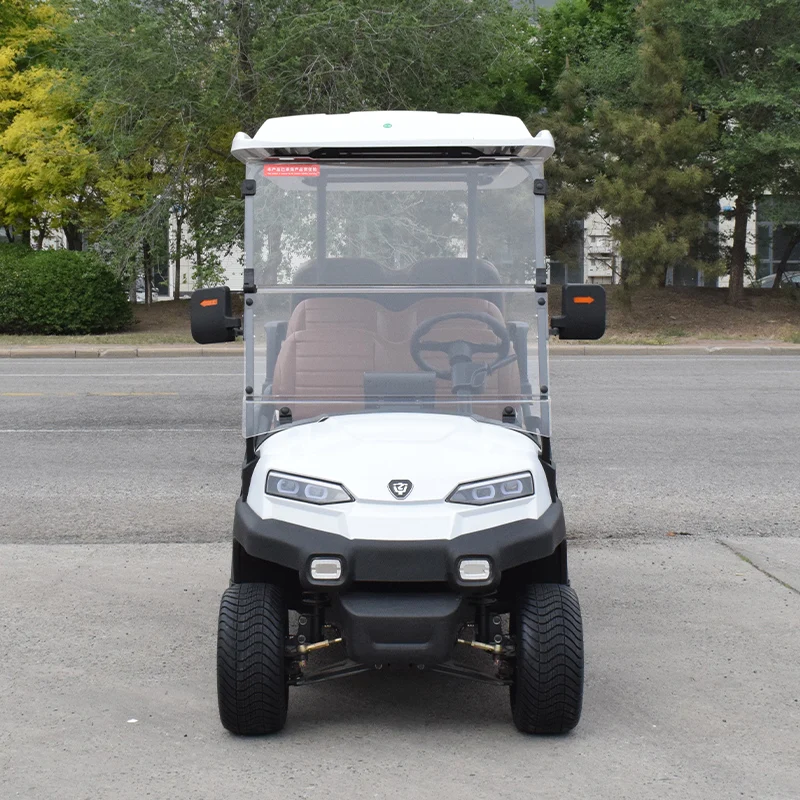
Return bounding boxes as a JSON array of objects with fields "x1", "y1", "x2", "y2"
[{"x1": 595, "y1": 0, "x2": 717, "y2": 286}]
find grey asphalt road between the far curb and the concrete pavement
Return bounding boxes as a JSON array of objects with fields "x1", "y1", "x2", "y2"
[{"x1": 0, "y1": 356, "x2": 800, "y2": 543}]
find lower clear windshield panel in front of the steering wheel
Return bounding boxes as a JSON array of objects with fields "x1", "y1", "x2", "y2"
[{"x1": 244, "y1": 287, "x2": 549, "y2": 436}]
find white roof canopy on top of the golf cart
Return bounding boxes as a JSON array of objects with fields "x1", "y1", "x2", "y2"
[{"x1": 231, "y1": 111, "x2": 555, "y2": 161}]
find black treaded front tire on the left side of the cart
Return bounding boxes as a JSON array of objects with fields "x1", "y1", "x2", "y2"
[{"x1": 217, "y1": 583, "x2": 289, "y2": 736}]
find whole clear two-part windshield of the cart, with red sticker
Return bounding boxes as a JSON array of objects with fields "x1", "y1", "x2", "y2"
[{"x1": 244, "y1": 160, "x2": 547, "y2": 436}]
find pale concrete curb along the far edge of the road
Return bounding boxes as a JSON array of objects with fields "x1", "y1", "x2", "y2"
[{"x1": 0, "y1": 344, "x2": 800, "y2": 358}]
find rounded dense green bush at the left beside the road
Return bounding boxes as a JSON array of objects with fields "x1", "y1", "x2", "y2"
[{"x1": 0, "y1": 250, "x2": 133, "y2": 334}]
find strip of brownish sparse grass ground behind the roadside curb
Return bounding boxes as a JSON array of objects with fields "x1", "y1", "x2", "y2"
[{"x1": 0, "y1": 286, "x2": 800, "y2": 347}]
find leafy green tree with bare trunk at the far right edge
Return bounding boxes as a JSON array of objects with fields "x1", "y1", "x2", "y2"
[{"x1": 665, "y1": 0, "x2": 800, "y2": 303}]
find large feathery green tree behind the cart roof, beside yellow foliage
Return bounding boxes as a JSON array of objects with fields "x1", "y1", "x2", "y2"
[{"x1": 60, "y1": 0, "x2": 533, "y2": 296}]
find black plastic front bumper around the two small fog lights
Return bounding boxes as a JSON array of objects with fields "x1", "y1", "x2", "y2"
[{"x1": 233, "y1": 498, "x2": 566, "y2": 592}]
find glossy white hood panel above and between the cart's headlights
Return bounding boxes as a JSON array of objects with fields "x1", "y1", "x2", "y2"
[{"x1": 259, "y1": 412, "x2": 539, "y2": 504}]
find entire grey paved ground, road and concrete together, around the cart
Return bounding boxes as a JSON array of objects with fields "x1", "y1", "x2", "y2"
[{"x1": 0, "y1": 356, "x2": 800, "y2": 800}]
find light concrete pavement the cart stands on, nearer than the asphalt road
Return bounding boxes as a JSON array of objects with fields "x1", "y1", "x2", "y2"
[{"x1": 0, "y1": 538, "x2": 800, "y2": 800}]
